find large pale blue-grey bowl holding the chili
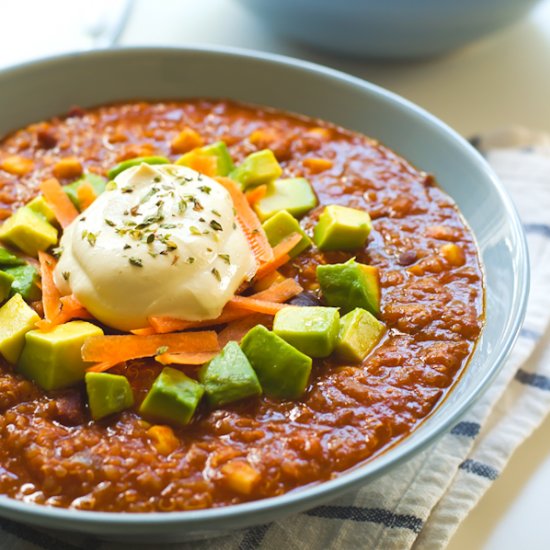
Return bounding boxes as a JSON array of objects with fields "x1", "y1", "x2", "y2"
[{"x1": 0, "y1": 48, "x2": 529, "y2": 543}]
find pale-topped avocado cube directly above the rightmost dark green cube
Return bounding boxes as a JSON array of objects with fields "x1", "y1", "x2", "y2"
[{"x1": 313, "y1": 204, "x2": 372, "y2": 250}]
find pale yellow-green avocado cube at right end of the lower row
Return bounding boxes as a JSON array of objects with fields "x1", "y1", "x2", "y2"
[{"x1": 334, "y1": 307, "x2": 385, "y2": 363}]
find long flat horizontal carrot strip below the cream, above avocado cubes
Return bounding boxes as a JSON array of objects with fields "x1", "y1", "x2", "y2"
[{"x1": 82, "y1": 331, "x2": 219, "y2": 363}]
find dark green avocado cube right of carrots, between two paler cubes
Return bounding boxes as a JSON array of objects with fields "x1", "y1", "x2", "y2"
[{"x1": 317, "y1": 258, "x2": 380, "y2": 315}]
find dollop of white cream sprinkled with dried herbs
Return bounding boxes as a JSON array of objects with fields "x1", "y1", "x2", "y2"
[{"x1": 54, "y1": 164, "x2": 256, "y2": 330}]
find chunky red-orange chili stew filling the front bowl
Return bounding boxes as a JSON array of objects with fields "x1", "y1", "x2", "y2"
[{"x1": 0, "y1": 100, "x2": 483, "y2": 512}]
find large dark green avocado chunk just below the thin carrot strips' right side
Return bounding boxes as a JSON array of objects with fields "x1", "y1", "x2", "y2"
[{"x1": 241, "y1": 325, "x2": 312, "y2": 399}]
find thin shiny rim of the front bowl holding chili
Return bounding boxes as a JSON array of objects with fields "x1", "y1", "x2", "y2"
[{"x1": 0, "y1": 44, "x2": 530, "y2": 532}]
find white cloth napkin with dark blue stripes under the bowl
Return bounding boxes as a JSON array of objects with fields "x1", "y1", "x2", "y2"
[{"x1": 0, "y1": 129, "x2": 550, "y2": 550}]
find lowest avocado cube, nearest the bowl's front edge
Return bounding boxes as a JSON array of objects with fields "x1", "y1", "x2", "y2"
[{"x1": 139, "y1": 367, "x2": 204, "y2": 426}]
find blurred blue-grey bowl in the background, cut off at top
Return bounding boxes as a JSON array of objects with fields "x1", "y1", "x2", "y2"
[{"x1": 239, "y1": 0, "x2": 539, "y2": 59}]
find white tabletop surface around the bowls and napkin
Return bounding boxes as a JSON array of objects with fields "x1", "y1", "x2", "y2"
[{"x1": 0, "y1": 0, "x2": 550, "y2": 550}]
